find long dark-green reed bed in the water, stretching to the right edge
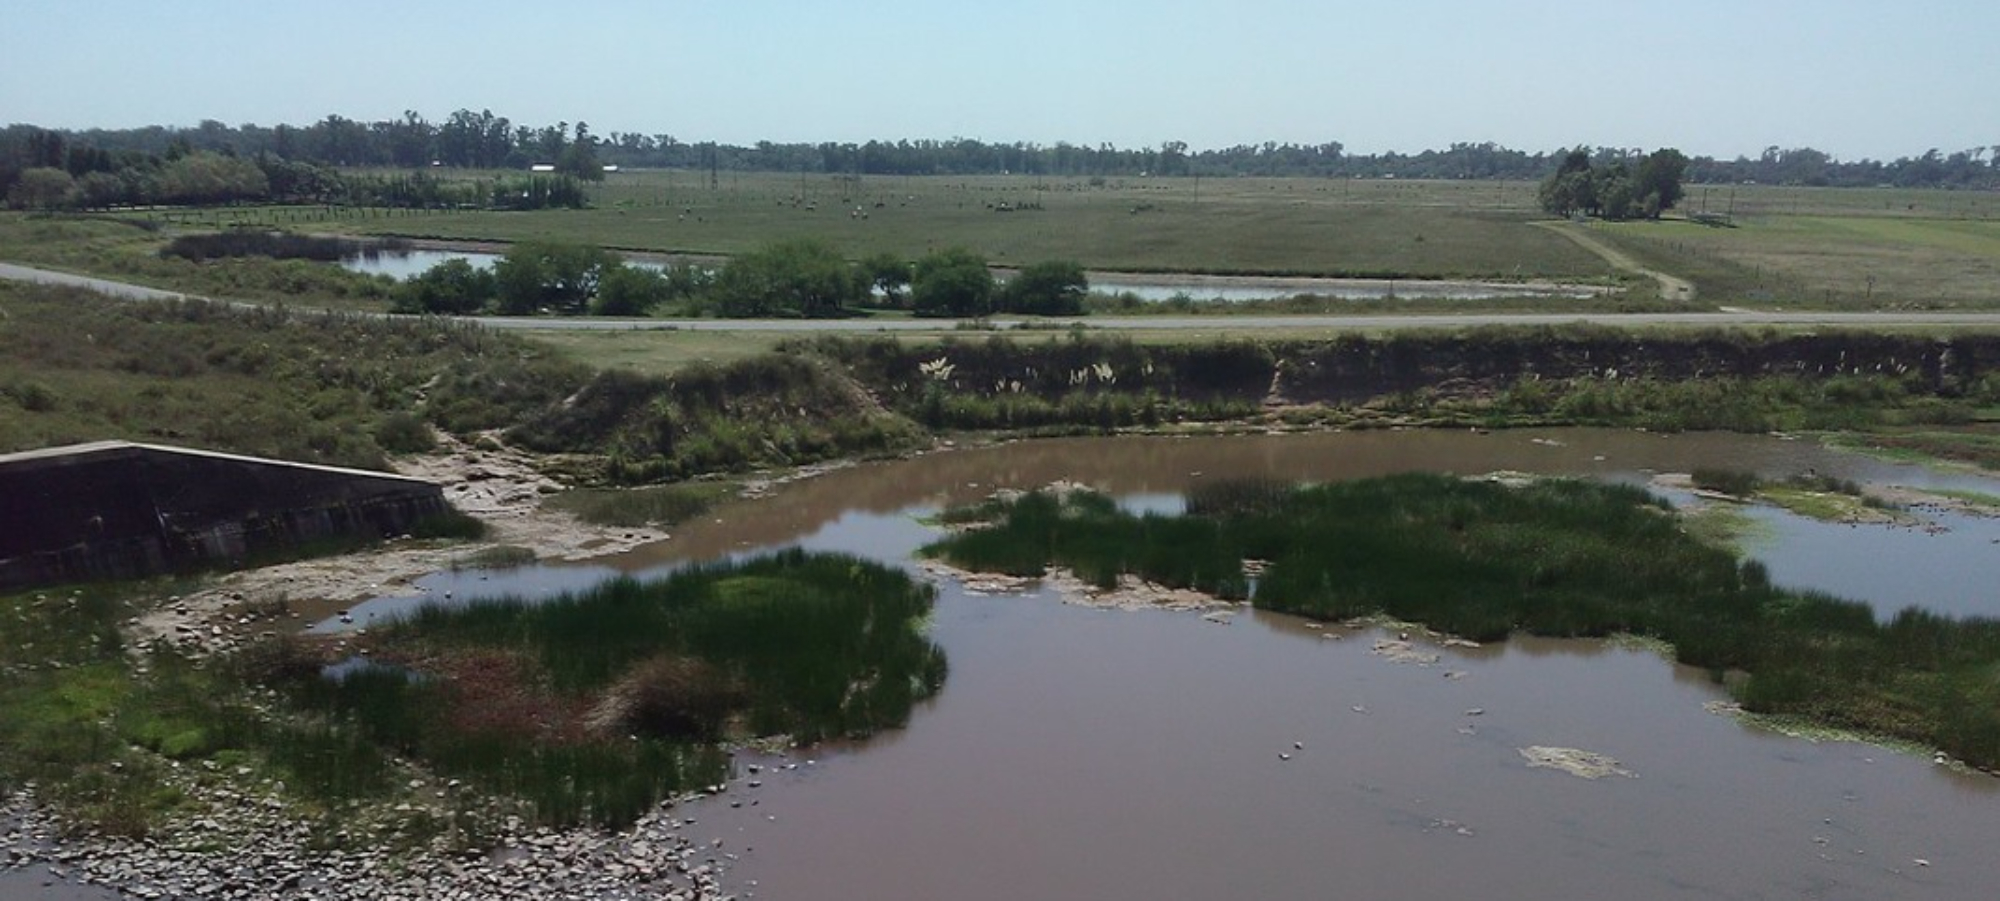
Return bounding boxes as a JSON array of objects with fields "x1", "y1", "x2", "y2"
[{"x1": 926, "y1": 475, "x2": 2000, "y2": 769}]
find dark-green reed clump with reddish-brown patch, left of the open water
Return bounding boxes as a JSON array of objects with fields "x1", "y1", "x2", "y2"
[{"x1": 248, "y1": 551, "x2": 944, "y2": 825}]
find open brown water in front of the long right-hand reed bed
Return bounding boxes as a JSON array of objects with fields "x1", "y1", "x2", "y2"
[{"x1": 688, "y1": 576, "x2": 2000, "y2": 901}]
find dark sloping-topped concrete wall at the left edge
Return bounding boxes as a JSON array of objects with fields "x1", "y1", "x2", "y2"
[{"x1": 0, "y1": 440, "x2": 450, "y2": 591}]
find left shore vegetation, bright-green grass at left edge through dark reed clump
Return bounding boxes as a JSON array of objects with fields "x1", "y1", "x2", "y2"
[{"x1": 0, "y1": 553, "x2": 944, "y2": 847}]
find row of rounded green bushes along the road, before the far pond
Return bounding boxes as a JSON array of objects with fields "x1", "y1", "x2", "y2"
[{"x1": 392, "y1": 240, "x2": 1090, "y2": 318}]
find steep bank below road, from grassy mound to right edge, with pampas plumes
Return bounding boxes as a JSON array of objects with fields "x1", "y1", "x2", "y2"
[{"x1": 510, "y1": 326, "x2": 2000, "y2": 481}]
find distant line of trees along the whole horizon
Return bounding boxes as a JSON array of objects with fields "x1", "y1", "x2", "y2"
[{"x1": 0, "y1": 110, "x2": 2000, "y2": 190}]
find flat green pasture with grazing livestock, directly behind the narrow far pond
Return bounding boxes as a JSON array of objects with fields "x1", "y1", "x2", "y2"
[{"x1": 320, "y1": 172, "x2": 1612, "y2": 278}]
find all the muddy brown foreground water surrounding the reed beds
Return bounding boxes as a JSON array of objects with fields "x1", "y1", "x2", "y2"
[{"x1": 322, "y1": 430, "x2": 2000, "y2": 901}]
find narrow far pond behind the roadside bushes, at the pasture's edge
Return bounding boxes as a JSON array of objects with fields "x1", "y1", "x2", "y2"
[{"x1": 342, "y1": 250, "x2": 1600, "y2": 302}]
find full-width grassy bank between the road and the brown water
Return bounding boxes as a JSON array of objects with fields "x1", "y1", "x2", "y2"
[{"x1": 15, "y1": 284, "x2": 2000, "y2": 483}]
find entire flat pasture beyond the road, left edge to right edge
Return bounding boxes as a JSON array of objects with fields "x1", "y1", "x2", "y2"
[{"x1": 0, "y1": 170, "x2": 2000, "y2": 312}]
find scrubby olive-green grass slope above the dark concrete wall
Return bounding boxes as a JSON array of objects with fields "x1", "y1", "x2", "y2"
[{"x1": 0, "y1": 282, "x2": 588, "y2": 469}]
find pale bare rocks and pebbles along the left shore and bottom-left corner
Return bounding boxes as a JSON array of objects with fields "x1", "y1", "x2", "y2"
[{"x1": 0, "y1": 432, "x2": 788, "y2": 901}]
